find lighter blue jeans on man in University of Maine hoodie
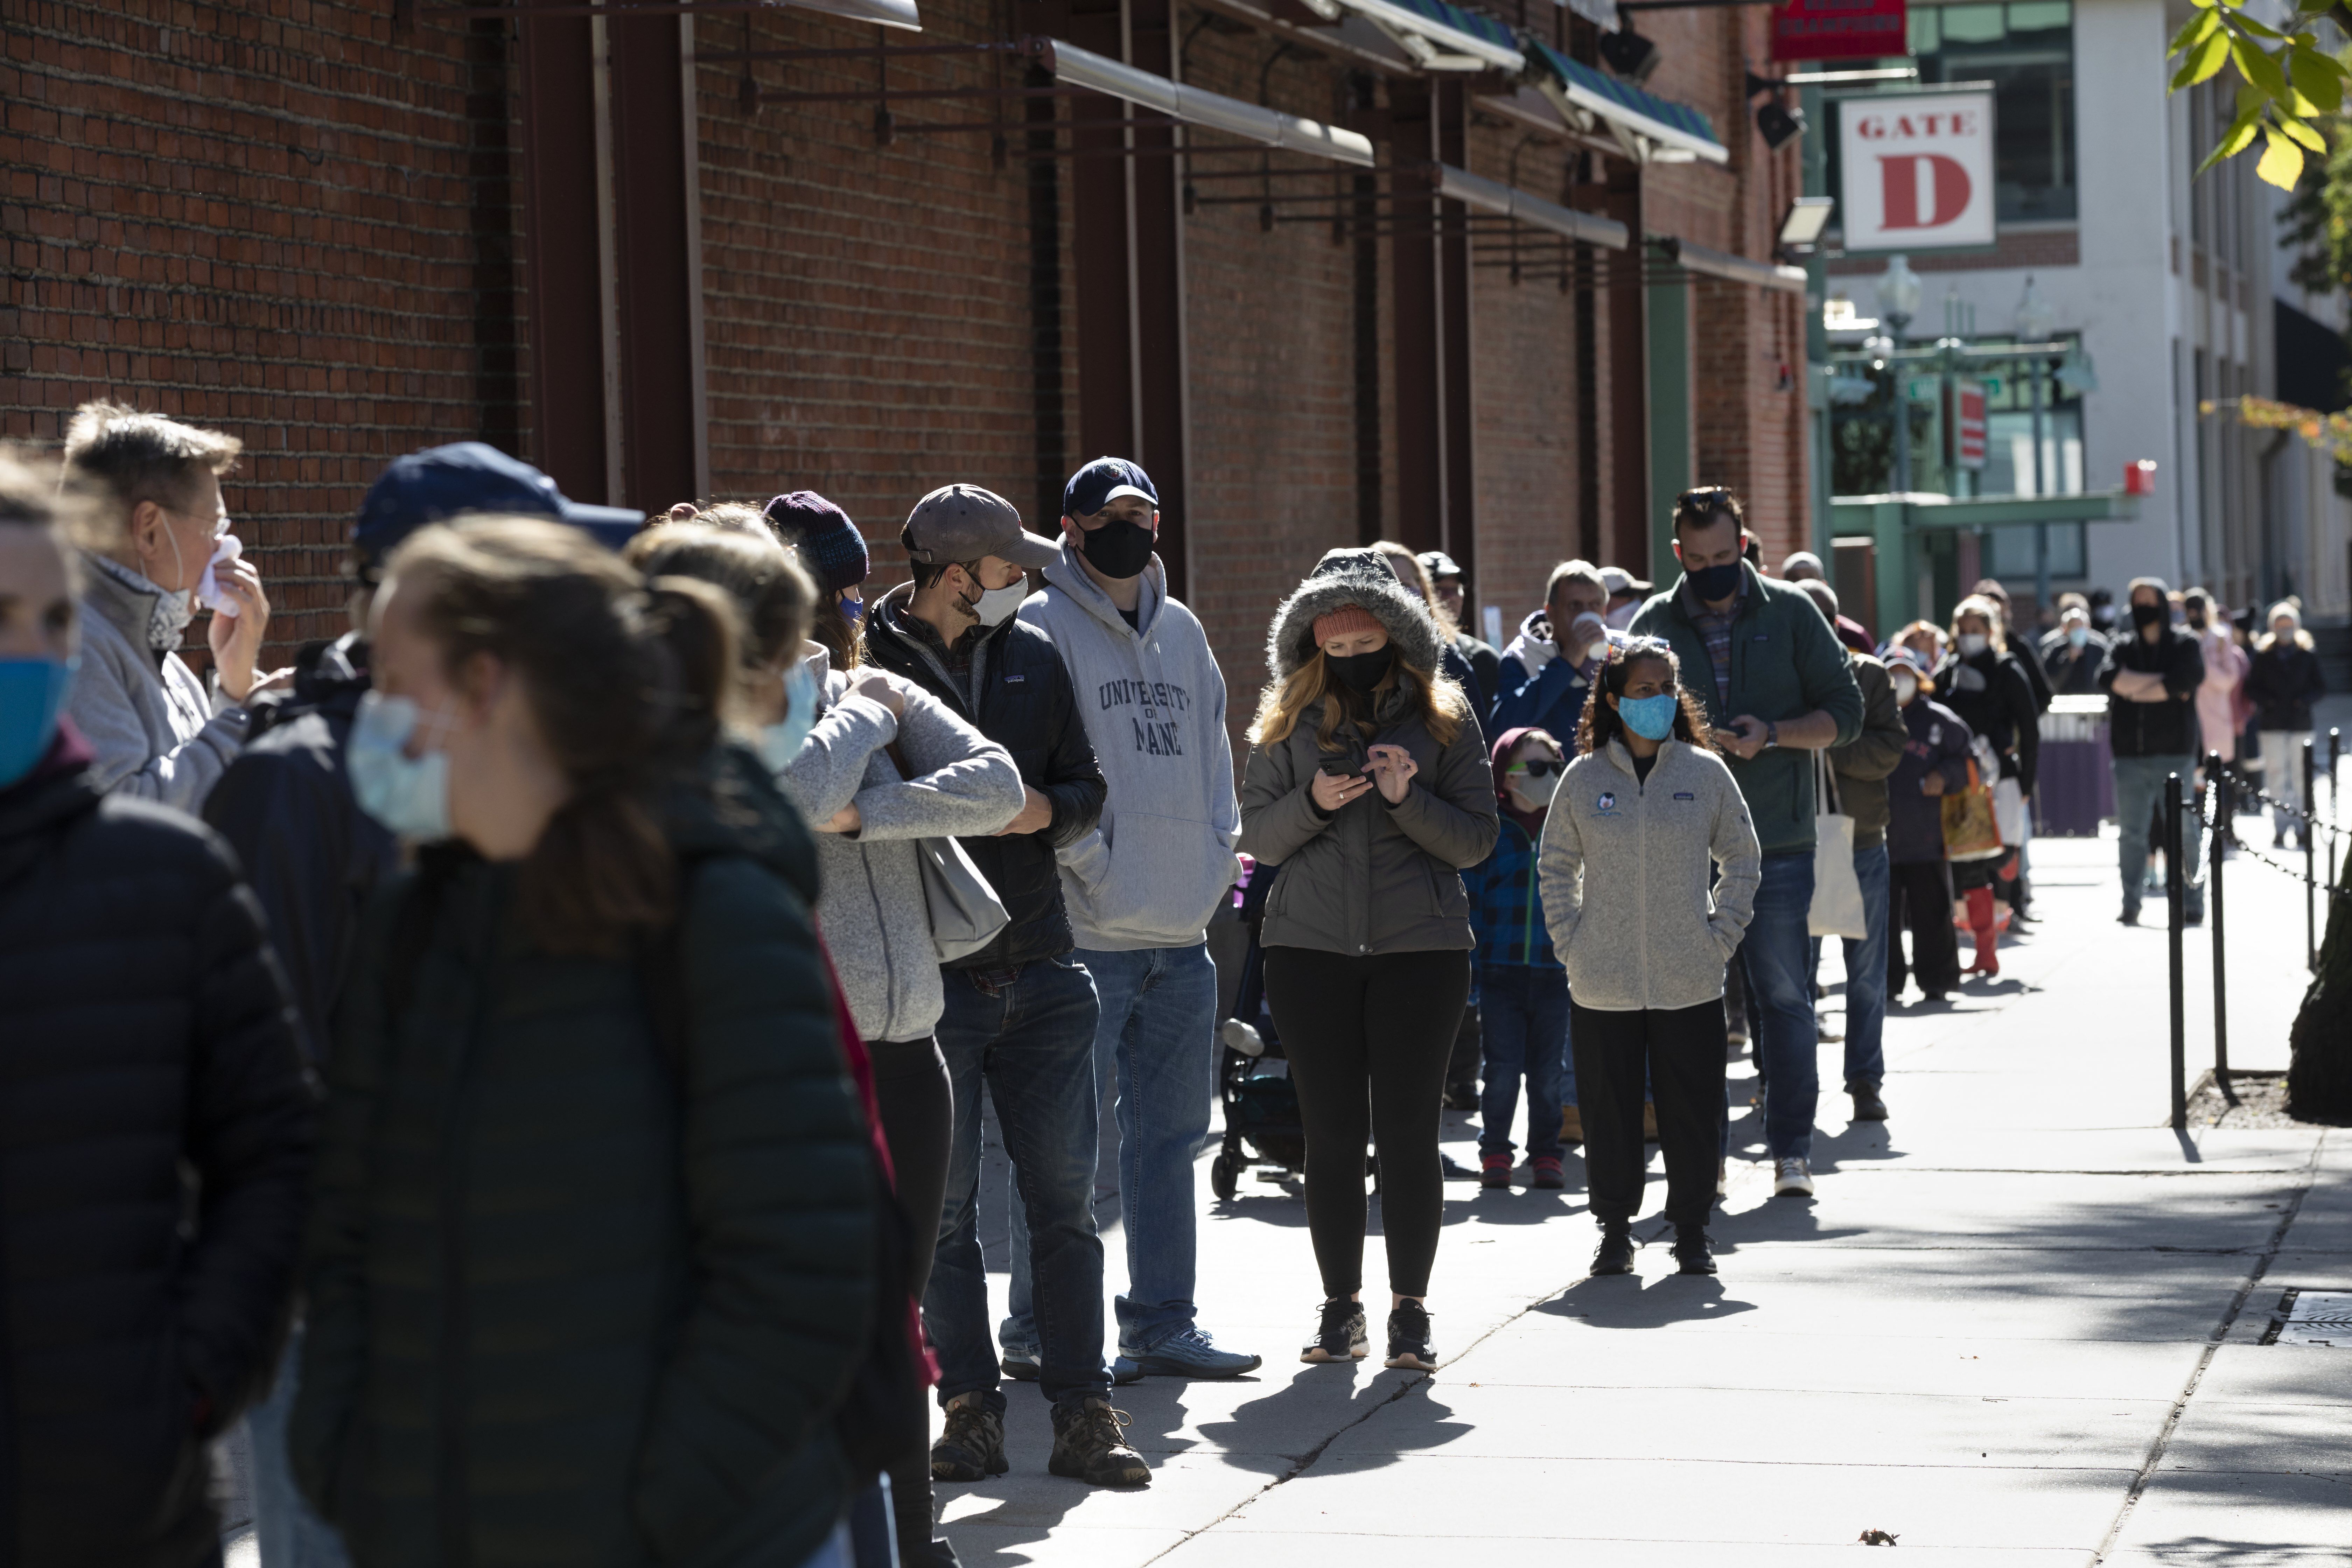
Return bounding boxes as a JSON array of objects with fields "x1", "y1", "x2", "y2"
[{"x1": 1002, "y1": 943, "x2": 1216, "y2": 1354}]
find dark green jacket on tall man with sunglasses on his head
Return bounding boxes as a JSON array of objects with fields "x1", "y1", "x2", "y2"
[{"x1": 1632, "y1": 567, "x2": 1863, "y2": 856}]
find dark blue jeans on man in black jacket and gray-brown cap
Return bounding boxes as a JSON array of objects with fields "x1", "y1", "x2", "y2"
[{"x1": 922, "y1": 959, "x2": 1110, "y2": 1408}]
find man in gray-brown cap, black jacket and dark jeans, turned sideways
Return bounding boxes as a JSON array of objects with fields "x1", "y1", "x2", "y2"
[{"x1": 866, "y1": 484, "x2": 1153, "y2": 1486}]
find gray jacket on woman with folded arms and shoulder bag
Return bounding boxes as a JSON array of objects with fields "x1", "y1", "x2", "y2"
[{"x1": 776, "y1": 642, "x2": 1028, "y2": 1039}]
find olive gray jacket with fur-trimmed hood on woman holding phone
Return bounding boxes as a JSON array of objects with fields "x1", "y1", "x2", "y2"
[{"x1": 1239, "y1": 550, "x2": 1500, "y2": 957}]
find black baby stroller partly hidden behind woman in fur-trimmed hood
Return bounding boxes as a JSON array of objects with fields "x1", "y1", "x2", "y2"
[{"x1": 1209, "y1": 865, "x2": 1308, "y2": 1199}]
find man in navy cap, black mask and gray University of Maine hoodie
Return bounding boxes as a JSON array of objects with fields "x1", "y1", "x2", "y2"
[{"x1": 1002, "y1": 458, "x2": 1261, "y2": 1380}]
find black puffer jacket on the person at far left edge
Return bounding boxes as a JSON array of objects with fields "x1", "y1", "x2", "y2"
[{"x1": 0, "y1": 731, "x2": 313, "y2": 1568}]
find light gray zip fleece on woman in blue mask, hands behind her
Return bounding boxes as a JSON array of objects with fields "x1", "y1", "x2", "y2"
[{"x1": 1536, "y1": 741, "x2": 1764, "y2": 1013}]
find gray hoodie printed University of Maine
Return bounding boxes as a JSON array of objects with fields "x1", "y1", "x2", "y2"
[{"x1": 1021, "y1": 538, "x2": 1242, "y2": 952}]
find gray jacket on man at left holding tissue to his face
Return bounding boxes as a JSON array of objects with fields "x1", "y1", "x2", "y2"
[{"x1": 66, "y1": 560, "x2": 247, "y2": 816}]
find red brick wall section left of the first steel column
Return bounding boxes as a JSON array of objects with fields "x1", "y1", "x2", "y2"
[{"x1": 0, "y1": 0, "x2": 525, "y2": 656}]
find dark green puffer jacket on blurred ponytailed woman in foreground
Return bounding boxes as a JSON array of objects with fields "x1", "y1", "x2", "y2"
[{"x1": 289, "y1": 759, "x2": 875, "y2": 1568}]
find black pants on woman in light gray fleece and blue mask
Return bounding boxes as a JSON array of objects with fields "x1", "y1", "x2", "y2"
[{"x1": 1569, "y1": 997, "x2": 1724, "y2": 1227}]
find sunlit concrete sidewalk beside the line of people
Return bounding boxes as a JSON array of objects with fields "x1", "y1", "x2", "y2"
[{"x1": 941, "y1": 834, "x2": 2352, "y2": 1568}]
